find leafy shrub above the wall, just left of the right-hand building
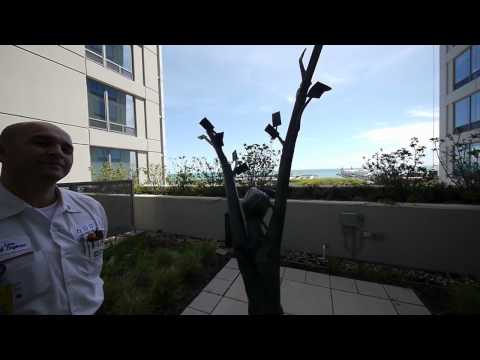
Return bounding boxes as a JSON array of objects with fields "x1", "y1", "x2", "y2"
[{"x1": 363, "y1": 137, "x2": 434, "y2": 188}]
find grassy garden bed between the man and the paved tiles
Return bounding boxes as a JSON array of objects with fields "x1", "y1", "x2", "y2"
[{"x1": 97, "y1": 231, "x2": 230, "y2": 315}]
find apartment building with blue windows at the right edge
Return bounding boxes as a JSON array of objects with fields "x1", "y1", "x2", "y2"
[{"x1": 439, "y1": 45, "x2": 480, "y2": 182}]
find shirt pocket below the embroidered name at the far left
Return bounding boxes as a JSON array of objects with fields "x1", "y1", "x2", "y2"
[{"x1": 0, "y1": 251, "x2": 52, "y2": 308}]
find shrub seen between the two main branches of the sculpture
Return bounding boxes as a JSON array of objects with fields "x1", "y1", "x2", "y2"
[{"x1": 240, "y1": 144, "x2": 280, "y2": 186}]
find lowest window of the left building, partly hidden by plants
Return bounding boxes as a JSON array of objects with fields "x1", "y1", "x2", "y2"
[{"x1": 90, "y1": 146, "x2": 138, "y2": 181}]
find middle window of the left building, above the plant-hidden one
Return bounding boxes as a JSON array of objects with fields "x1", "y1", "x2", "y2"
[{"x1": 87, "y1": 79, "x2": 137, "y2": 136}]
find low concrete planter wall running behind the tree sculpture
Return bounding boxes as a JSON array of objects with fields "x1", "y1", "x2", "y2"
[{"x1": 135, "y1": 195, "x2": 480, "y2": 276}]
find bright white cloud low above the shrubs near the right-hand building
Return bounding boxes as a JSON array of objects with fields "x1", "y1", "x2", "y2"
[{"x1": 354, "y1": 121, "x2": 433, "y2": 151}]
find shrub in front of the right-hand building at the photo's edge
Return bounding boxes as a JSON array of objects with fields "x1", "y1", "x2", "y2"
[{"x1": 430, "y1": 133, "x2": 480, "y2": 190}]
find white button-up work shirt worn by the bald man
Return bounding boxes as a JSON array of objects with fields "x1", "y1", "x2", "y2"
[{"x1": 0, "y1": 183, "x2": 108, "y2": 315}]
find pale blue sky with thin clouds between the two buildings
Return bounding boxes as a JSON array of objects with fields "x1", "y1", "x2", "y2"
[{"x1": 163, "y1": 45, "x2": 439, "y2": 171}]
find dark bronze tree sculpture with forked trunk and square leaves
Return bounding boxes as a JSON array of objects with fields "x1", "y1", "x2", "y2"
[{"x1": 199, "y1": 45, "x2": 330, "y2": 315}]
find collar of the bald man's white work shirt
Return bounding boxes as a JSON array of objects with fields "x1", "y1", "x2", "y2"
[{"x1": 0, "y1": 182, "x2": 81, "y2": 220}]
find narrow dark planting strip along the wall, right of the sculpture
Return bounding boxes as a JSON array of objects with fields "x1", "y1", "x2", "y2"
[{"x1": 281, "y1": 251, "x2": 480, "y2": 315}]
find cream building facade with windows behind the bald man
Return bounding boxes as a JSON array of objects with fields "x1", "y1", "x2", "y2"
[{"x1": 0, "y1": 45, "x2": 165, "y2": 182}]
